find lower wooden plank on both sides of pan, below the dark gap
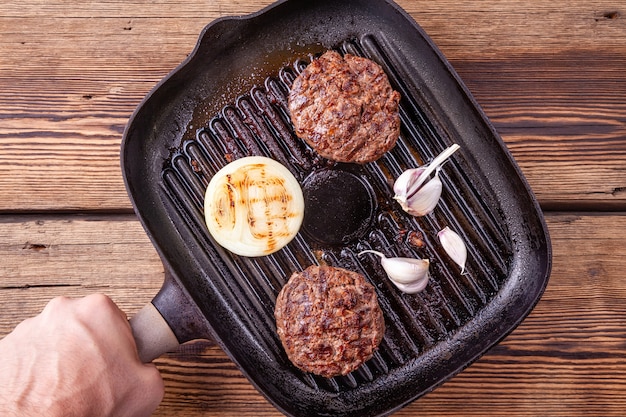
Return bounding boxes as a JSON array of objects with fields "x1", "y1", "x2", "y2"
[{"x1": 0, "y1": 213, "x2": 626, "y2": 417}]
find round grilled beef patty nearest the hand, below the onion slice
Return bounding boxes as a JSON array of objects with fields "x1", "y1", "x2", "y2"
[{"x1": 274, "y1": 265, "x2": 385, "y2": 378}]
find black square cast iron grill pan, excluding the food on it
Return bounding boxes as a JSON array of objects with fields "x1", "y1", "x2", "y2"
[{"x1": 121, "y1": 0, "x2": 551, "y2": 416}]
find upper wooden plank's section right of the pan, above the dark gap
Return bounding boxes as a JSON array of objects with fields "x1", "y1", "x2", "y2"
[{"x1": 399, "y1": 0, "x2": 626, "y2": 210}]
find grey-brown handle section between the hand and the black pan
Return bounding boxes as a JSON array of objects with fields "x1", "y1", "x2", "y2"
[{"x1": 129, "y1": 303, "x2": 179, "y2": 363}]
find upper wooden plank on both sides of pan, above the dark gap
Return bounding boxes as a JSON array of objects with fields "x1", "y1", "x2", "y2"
[{"x1": 0, "y1": 0, "x2": 626, "y2": 212}]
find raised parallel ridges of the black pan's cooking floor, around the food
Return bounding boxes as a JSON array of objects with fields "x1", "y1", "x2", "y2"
[{"x1": 163, "y1": 36, "x2": 511, "y2": 392}]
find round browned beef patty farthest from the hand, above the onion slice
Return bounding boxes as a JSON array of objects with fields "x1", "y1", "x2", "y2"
[{"x1": 289, "y1": 51, "x2": 400, "y2": 164}]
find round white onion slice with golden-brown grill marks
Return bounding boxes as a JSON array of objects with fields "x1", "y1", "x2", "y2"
[{"x1": 204, "y1": 156, "x2": 304, "y2": 256}]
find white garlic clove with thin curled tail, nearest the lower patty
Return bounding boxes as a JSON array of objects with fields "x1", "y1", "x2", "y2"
[{"x1": 359, "y1": 250, "x2": 430, "y2": 294}]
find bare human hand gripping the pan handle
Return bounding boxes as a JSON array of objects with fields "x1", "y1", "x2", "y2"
[{"x1": 0, "y1": 295, "x2": 164, "y2": 417}]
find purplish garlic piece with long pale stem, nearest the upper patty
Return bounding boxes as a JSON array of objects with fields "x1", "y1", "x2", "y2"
[{"x1": 393, "y1": 143, "x2": 460, "y2": 216}]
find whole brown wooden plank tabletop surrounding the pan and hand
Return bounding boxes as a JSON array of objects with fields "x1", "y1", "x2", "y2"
[{"x1": 0, "y1": 0, "x2": 626, "y2": 417}]
